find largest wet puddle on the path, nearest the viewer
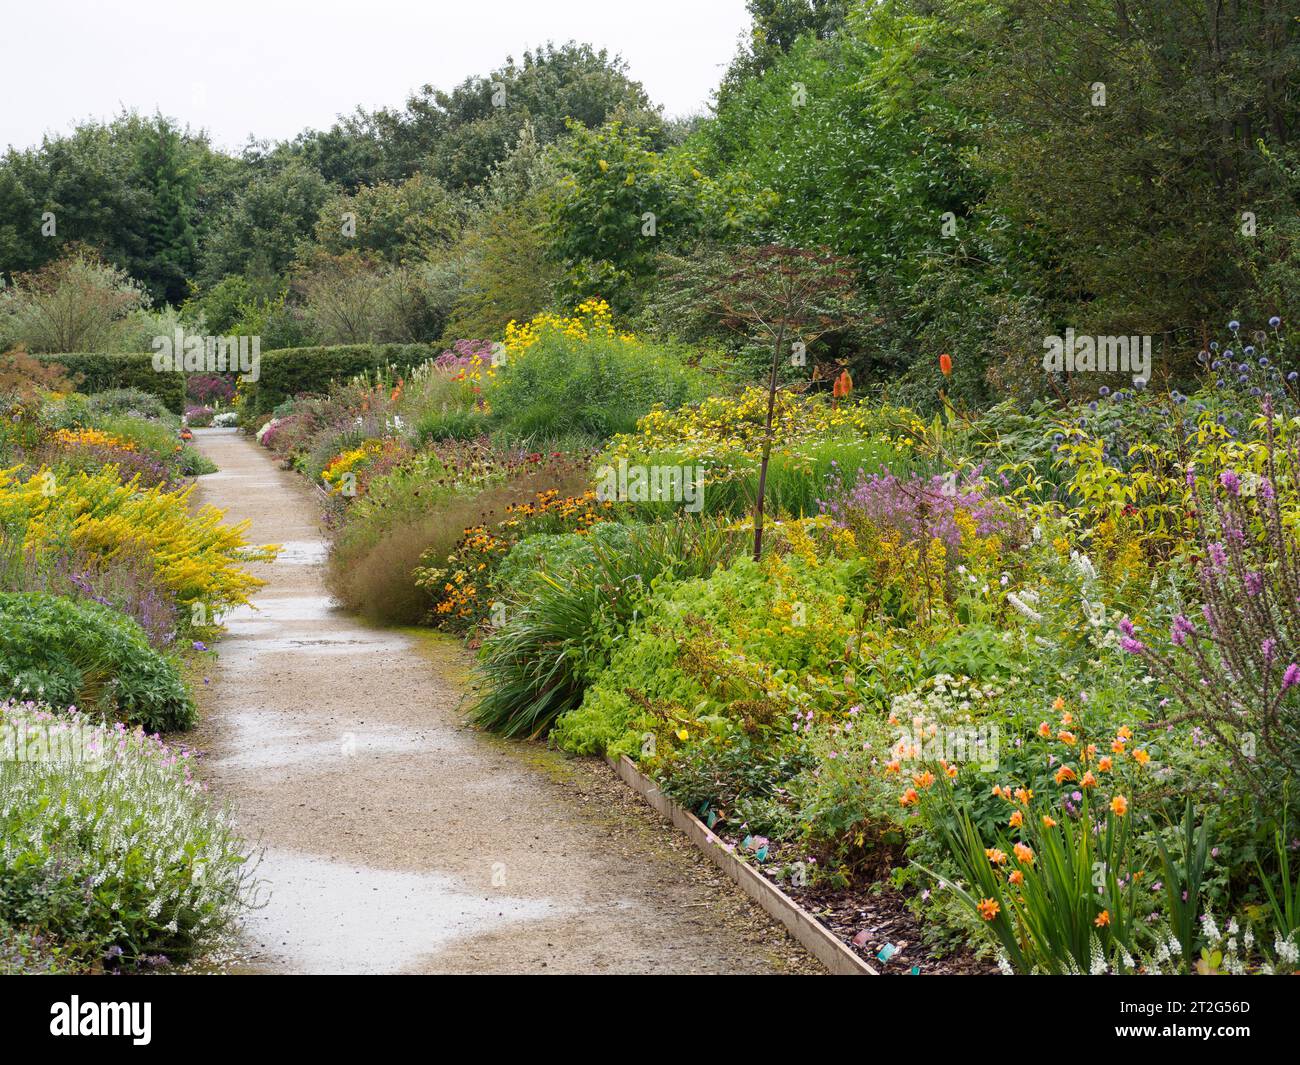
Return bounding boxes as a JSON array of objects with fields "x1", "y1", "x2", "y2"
[{"x1": 246, "y1": 849, "x2": 568, "y2": 974}]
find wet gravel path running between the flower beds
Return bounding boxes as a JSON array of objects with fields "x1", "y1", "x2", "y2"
[{"x1": 192, "y1": 429, "x2": 822, "y2": 974}]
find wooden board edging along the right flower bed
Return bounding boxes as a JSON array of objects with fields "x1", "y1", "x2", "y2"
[{"x1": 606, "y1": 754, "x2": 878, "y2": 977}]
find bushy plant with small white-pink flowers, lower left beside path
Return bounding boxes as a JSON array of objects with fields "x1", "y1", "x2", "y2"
[{"x1": 0, "y1": 703, "x2": 252, "y2": 973}]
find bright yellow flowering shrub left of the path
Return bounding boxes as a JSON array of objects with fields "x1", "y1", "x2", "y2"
[{"x1": 0, "y1": 467, "x2": 278, "y2": 614}]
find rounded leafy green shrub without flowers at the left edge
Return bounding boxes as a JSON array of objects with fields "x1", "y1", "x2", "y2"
[{"x1": 0, "y1": 592, "x2": 195, "y2": 732}]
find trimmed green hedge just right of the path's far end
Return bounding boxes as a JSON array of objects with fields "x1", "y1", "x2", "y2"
[{"x1": 239, "y1": 343, "x2": 438, "y2": 419}]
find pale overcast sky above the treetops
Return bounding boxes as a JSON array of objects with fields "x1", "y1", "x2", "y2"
[{"x1": 0, "y1": 0, "x2": 749, "y2": 148}]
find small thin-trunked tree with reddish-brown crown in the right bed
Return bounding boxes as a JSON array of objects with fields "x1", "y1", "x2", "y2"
[{"x1": 680, "y1": 244, "x2": 857, "y2": 562}]
